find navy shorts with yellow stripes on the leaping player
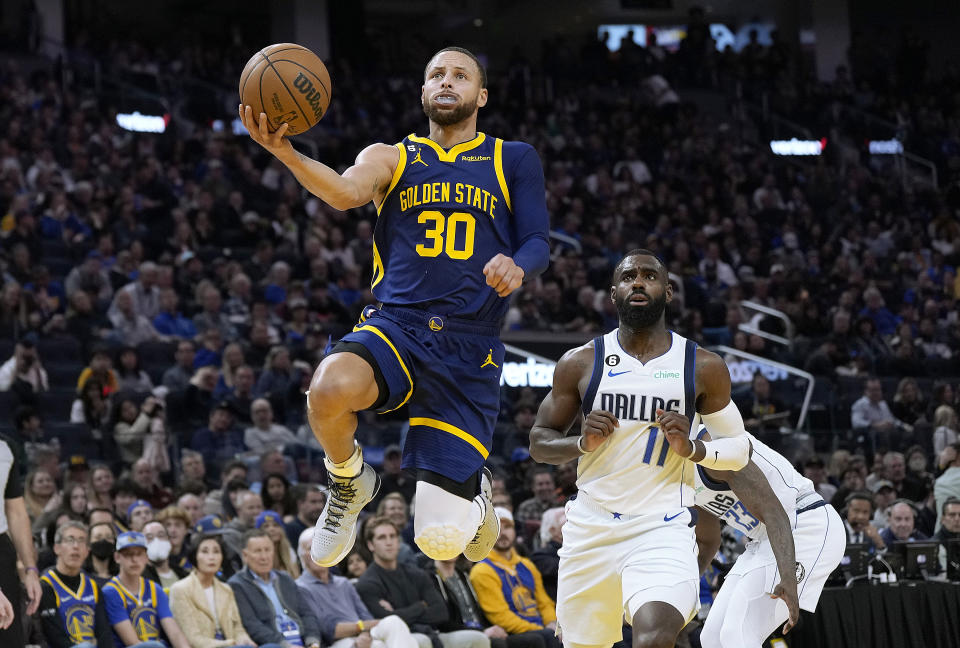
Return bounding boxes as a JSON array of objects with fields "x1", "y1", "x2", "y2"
[{"x1": 341, "y1": 306, "x2": 504, "y2": 482}]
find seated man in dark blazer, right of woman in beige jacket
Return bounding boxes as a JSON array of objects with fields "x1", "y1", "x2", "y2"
[{"x1": 228, "y1": 529, "x2": 320, "y2": 648}]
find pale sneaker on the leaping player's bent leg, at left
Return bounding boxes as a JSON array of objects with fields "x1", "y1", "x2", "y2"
[{"x1": 310, "y1": 463, "x2": 380, "y2": 567}]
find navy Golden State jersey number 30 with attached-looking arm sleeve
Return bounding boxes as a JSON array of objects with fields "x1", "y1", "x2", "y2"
[{"x1": 372, "y1": 133, "x2": 548, "y2": 322}]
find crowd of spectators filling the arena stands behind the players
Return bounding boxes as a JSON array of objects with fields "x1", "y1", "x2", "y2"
[{"x1": 0, "y1": 10, "x2": 960, "y2": 648}]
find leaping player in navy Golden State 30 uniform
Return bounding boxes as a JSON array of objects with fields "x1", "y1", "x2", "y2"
[{"x1": 240, "y1": 47, "x2": 549, "y2": 566}]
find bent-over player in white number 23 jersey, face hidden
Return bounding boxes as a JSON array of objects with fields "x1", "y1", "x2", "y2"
[{"x1": 695, "y1": 430, "x2": 847, "y2": 648}]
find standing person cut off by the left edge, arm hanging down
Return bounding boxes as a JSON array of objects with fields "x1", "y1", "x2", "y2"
[{"x1": 0, "y1": 435, "x2": 40, "y2": 648}]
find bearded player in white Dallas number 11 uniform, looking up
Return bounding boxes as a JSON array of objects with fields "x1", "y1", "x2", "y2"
[{"x1": 530, "y1": 250, "x2": 750, "y2": 648}]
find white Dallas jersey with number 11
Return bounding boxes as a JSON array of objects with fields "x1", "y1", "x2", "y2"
[{"x1": 577, "y1": 329, "x2": 700, "y2": 515}]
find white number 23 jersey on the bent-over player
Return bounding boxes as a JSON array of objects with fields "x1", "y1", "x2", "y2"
[{"x1": 695, "y1": 430, "x2": 823, "y2": 540}]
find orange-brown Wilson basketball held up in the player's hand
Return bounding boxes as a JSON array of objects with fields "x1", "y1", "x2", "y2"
[{"x1": 240, "y1": 43, "x2": 331, "y2": 135}]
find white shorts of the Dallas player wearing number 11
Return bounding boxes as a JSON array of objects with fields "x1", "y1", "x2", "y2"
[{"x1": 557, "y1": 491, "x2": 700, "y2": 645}]
